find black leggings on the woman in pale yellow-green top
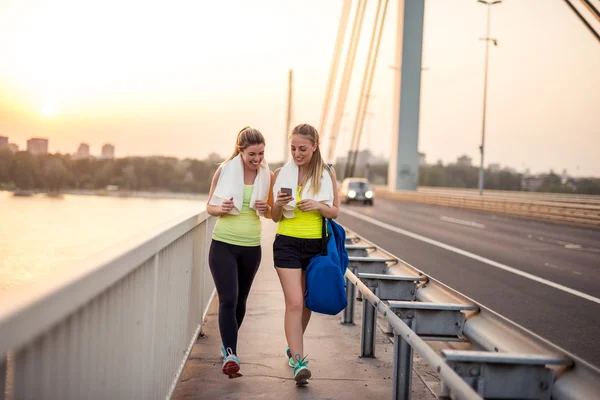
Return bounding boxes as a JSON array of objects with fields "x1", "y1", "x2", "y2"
[{"x1": 208, "y1": 240, "x2": 261, "y2": 354}]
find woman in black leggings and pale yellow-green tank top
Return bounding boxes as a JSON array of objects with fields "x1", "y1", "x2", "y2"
[{"x1": 206, "y1": 127, "x2": 272, "y2": 377}]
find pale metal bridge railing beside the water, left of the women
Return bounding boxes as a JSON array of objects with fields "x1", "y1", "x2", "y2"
[{"x1": 0, "y1": 212, "x2": 215, "y2": 400}]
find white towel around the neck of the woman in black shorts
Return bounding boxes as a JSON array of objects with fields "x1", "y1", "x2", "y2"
[{"x1": 273, "y1": 160, "x2": 333, "y2": 218}]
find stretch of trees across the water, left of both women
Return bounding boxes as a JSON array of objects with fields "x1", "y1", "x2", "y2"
[{"x1": 0, "y1": 149, "x2": 222, "y2": 193}]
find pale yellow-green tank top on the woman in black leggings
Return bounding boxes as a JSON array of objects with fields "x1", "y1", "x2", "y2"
[{"x1": 213, "y1": 185, "x2": 261, "y2": 247}]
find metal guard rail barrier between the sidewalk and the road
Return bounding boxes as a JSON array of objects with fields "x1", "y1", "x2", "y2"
[{"x1": 342, "y1": 230, "x2": 600, "y2": 400}]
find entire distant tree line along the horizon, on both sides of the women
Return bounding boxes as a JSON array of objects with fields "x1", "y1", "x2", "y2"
[{"x1": 0, "y1": 149, "x2": 600, "y2": 195}]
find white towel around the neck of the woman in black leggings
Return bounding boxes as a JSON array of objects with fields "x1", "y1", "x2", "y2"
[{"x1": 209, "y1": 154, "x2": 271, "y2": 216}]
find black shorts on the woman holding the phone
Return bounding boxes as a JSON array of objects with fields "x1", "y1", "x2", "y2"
[{"x1": 273, "y1": 234, "x2": 322, "y2": 270}]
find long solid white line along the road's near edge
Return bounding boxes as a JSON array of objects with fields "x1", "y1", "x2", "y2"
[{"x1": 340, "y1": 207, "x2": 600, "y2": 304}]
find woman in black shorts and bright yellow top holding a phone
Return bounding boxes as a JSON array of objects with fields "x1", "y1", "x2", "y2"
[{"x1": 271, "y1": 124, "x2": 339, "y2": 385}]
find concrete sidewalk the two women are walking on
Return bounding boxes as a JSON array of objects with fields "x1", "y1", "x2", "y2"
[{"x1": 173, "y1": 221, "x2": 437, "y2": 400}]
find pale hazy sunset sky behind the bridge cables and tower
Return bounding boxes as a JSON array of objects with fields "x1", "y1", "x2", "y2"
[{"x1": 0, "y1": 0, "x2": 600, "y2": 176}]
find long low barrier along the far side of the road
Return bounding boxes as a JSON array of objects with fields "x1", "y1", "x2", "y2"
[{"x1": 376, "y1": 188, "x2": 600, "y2": 227}]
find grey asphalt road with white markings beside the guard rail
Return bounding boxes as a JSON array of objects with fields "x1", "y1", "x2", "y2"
[{"x1": 338, "y1": 199, "x2": 600, "y2": 366}]
